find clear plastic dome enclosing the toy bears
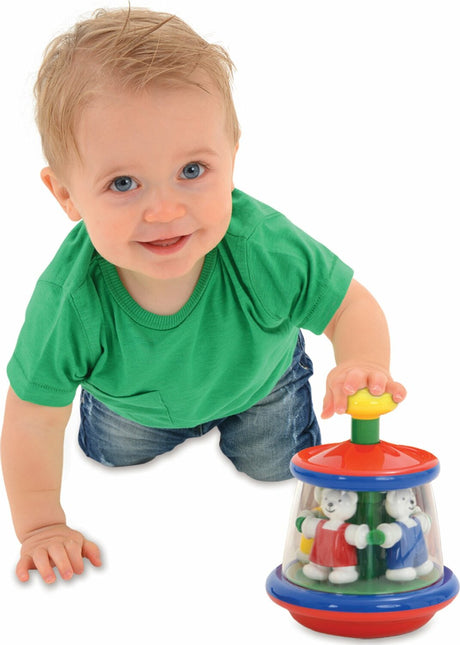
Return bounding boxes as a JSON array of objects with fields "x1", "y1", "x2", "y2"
[{"x1": 282, "y1": 481, "x2": 443, "y2": 595}]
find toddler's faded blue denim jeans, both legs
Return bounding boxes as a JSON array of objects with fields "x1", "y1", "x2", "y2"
[{"x1": 78, "y1": 333, "x2": 320, "y2": 481}]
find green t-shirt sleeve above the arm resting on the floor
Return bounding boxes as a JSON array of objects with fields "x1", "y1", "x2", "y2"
[{"x1": 7, "y1": 281, "x2": 98, "y2": 407}]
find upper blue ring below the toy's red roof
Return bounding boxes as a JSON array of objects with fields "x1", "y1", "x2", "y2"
[{"x1": 291, "y1": 462, "x2": 440, "y2": 491}]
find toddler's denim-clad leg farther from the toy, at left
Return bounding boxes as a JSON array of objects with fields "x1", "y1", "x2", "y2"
[{"x1": 78, "y1": 390, "x2": 204, "y2": 466}]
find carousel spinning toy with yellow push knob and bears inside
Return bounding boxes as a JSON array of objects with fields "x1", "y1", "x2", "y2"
[{"x1": 266, "y1": 390, "x2": 459, "y2": 638}]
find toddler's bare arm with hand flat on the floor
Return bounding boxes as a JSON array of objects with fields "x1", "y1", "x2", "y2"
[{"x1": 2, "y1": 388, "x2": 100, "y2": 583}]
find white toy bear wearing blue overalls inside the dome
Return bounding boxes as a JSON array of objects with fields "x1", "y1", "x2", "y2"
[{"x1": 377, "y1": 488, "x2": 434, "y2": 581}]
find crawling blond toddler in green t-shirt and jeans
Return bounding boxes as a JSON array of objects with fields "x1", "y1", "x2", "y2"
[{"x1": 2, "y1": 9, "x2": 405, "y2": 583}]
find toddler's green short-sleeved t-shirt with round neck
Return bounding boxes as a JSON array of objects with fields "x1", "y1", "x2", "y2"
[{"x1": 8, "y1": 190, "x2": 352, "y2": 428}]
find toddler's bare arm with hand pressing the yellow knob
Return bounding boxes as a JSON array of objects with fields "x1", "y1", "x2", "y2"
[{"x1": 322, "y1": 280, "x2": 406, "y2": 419}]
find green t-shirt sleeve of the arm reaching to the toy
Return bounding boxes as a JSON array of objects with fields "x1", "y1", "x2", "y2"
[{"x1": 248, "y1": 213, "x2": 353, "y2": 334}]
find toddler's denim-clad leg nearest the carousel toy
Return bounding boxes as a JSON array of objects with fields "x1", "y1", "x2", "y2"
[{"x1": 219, "y1": 334, "x2": 321, "y2": 481}]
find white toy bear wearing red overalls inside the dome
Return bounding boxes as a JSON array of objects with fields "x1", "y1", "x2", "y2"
[{"x1": 298, "y1": 488, "x2": 369, "y2": 584}]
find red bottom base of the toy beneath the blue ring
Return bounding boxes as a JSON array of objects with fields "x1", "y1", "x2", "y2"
[{"x1": 275, "y1": 600, "x2": 451, "y2": 638}]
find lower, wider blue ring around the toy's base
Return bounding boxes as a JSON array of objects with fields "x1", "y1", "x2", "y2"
[{"x1": 266, "y1": 565, "x2": 459, "y2": 614}]
